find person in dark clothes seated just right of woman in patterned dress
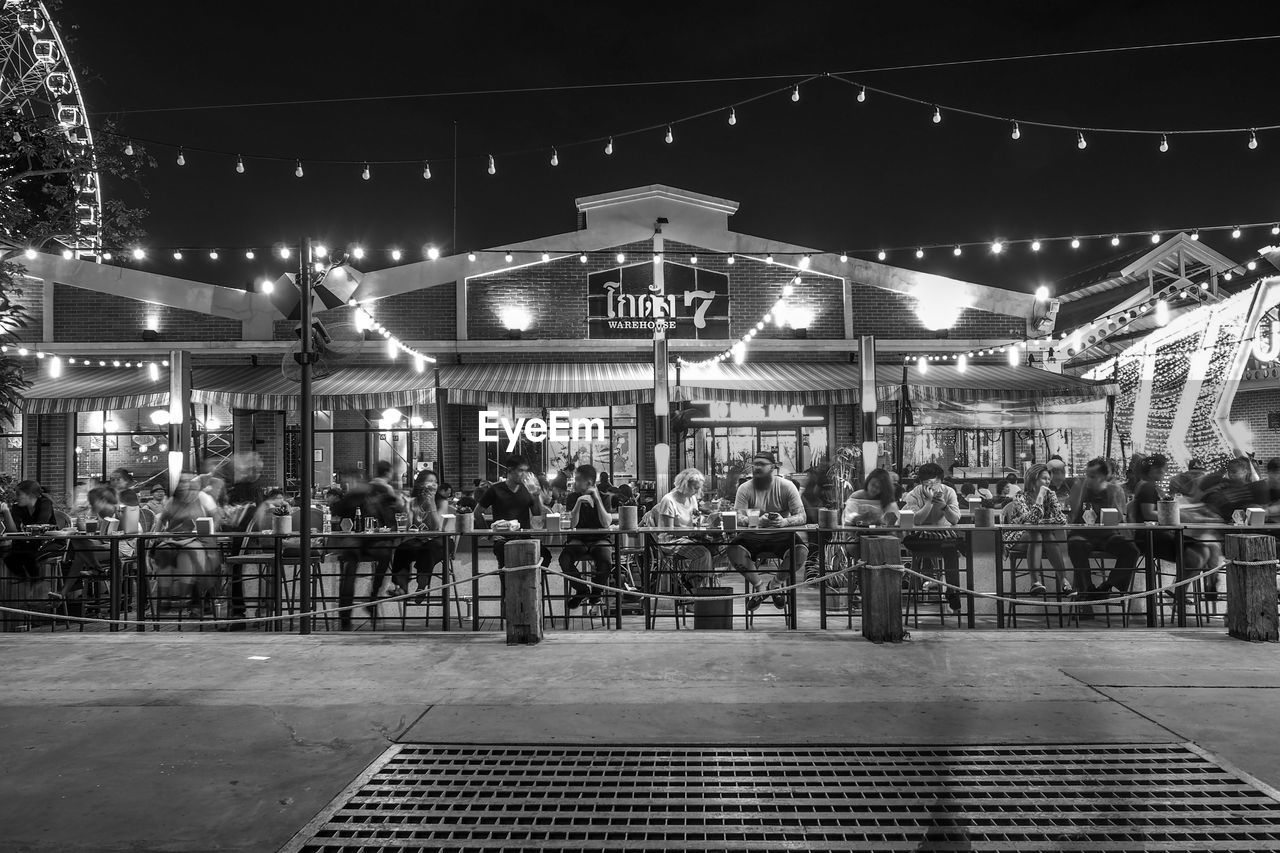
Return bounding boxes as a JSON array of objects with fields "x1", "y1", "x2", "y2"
[{"x1": 1066, "y1": 459, "x2": 1140, "y2": 594}]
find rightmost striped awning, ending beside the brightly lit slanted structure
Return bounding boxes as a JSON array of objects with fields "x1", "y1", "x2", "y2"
[{"x1": 876, "y1": 364, "x2": 1115, "y2": 402}]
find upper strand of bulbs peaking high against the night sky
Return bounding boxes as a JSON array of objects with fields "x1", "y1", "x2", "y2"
[{"x1": 99, "y1": 73, "x2": 1280, "y2": 181}]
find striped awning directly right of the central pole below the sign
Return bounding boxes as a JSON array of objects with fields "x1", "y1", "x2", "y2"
[{"x1": 673, "y1": 361, "x2": 859, "y2": 406}]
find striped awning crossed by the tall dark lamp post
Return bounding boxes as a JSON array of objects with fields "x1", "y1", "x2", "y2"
[{"x1": 191, "y1": 366, "x2": 435, "y2": 411}]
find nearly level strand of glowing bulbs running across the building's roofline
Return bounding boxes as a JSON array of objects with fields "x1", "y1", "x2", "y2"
[{"x1": 24, "y1": 220, "x2": 1280, "y2": 268}]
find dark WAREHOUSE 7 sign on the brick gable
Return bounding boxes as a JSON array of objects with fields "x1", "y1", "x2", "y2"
[{"x1": 586, "y1": 261, "x2": 730, "y2": 339}]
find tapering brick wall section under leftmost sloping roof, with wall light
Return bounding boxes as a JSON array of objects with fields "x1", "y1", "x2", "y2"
[{"x1": 54, "y1": 284, "x2": 242, "y2": 342}]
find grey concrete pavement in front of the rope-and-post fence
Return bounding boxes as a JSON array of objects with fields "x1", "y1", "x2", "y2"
[{"x1": 0, "y1": 629, "x2": 1280, "y2": 853}]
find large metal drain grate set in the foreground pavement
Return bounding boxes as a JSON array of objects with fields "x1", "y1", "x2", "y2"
[{"x1": 284, "y1": 744, "x2": 1280, "y2": 853}]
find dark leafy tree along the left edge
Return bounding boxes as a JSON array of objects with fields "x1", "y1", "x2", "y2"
[{"x1": 0, "y1": 3, "x2": 155, "y2": 423}]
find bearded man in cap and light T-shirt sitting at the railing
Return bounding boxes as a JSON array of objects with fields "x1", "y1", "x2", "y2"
[{"x1": 727, "y1": 451, "x2": 809, "y2": 610}]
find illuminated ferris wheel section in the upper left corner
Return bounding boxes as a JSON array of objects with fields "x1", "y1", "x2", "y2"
[{"x1": 0, "y1": 0, "x2": 102, "y2": 255}]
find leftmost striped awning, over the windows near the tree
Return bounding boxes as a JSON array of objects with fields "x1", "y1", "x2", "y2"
[{"x1": 22, "y1": 365, "x2": 169, "y2": 415}]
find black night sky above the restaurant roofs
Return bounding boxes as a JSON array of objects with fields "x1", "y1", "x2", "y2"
[{"x1": 60, "y1": 1, "x2": 1280, "y2": 291}]
